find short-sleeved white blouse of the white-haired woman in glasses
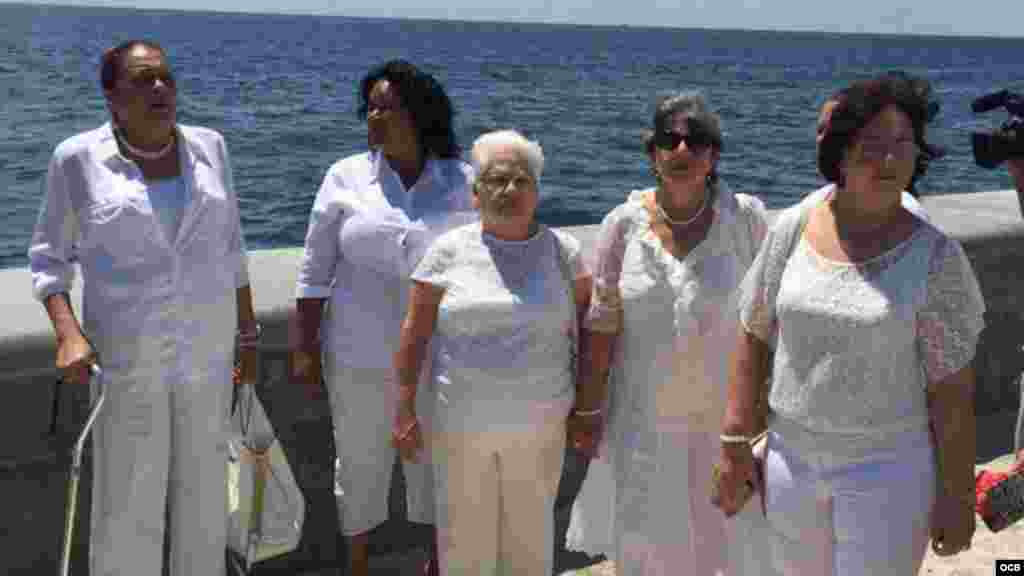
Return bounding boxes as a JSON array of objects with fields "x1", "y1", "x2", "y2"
[{"x1": 413, "y1": 223, "x2": 588, "y2": 430}]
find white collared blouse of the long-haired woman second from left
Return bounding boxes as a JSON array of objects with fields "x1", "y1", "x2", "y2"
[{"x1": 296, "y1": 151, "x2": 477, "y2": 369}]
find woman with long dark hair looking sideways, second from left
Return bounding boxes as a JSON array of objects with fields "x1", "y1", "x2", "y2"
[{"x1": 293, "y1": 60, "x2": 475, "y2": 576}]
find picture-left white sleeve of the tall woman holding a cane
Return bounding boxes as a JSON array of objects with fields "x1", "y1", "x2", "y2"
[{"x1": 29, "y1": 148, "x2": 79, "y2": 300}]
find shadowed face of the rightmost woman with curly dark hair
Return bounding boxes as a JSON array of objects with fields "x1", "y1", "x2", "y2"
[{"x1": 840, "y1": 105, "x2": 920, "y2": 195}]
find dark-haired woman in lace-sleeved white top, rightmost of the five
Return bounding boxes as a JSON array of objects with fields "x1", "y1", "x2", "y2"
[{"x1": 719, "y1": 76, "x2": 984, "y2": 576}]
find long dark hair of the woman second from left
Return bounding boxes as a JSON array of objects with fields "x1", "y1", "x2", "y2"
[{"x1": 358, "y1": 59, "x2": 462, "y2": 158}]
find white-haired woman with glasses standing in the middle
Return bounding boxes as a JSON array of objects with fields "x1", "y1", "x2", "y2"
[{"x1": 393, "y1": 130, "x2": 591, "y2": 576}]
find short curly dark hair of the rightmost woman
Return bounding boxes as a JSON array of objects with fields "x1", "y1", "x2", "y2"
[{"x1": 818, "y1": 72, "x2": 945, "y2": 189}]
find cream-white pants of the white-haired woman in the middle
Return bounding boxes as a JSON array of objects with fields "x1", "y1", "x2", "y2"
[{"x1": 431, "y1": 418, "x2": 565, "y2": 576}]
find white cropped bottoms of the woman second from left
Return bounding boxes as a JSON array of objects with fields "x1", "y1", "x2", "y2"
[{"x1": 328, "y1": 366, "x2": 434, "y2": 536}]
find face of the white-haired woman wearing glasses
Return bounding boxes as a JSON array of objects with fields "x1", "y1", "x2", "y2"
[{"x1": 473, "y1": 148, "x2": 540, "y2": 225}]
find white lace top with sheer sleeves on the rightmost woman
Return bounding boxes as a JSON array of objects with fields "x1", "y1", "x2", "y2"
[{"x1": 740, "y1": 201, "x2": 985, "y2": 460}]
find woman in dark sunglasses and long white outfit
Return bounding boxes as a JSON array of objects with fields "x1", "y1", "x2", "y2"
[{"x1": 568, "y1": 93, "x2": 767, "y2": 576}]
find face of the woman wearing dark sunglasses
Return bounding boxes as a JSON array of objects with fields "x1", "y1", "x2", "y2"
[{"x1": 651, "y1": 113, "x2": 717, "y2": 186}]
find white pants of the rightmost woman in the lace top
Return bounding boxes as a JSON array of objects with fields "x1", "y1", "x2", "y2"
[{"x1": 765, "y1": 433, "x2": 936, "y2": 576}]
